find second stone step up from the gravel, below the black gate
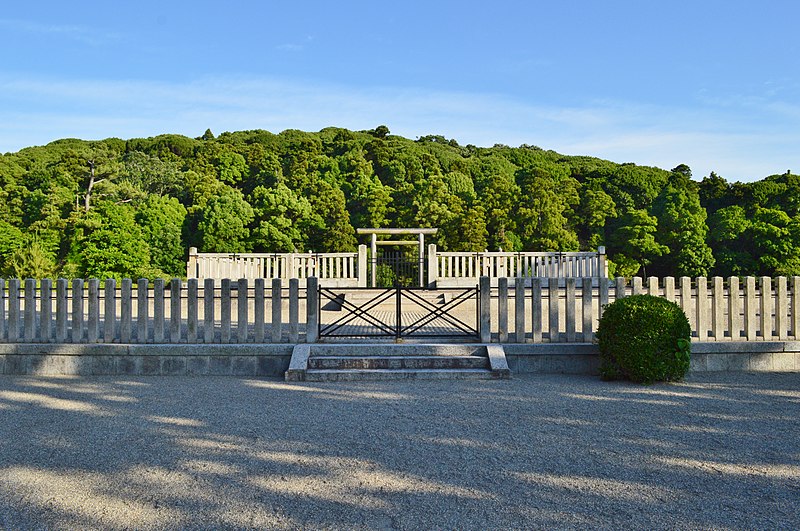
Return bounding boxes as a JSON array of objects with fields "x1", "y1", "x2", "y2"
[{"x1": 308, "y1": 355, "x2": 489, "y2": 369}]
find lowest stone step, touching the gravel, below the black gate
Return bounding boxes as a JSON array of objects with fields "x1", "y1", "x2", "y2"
[{"x1": 305, "y1": 369, "x2": 497, "y2": 382}]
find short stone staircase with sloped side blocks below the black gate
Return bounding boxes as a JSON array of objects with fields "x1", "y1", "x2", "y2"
[{"x1": 285, "y1": 343, "x2": 511, "y2": 382}]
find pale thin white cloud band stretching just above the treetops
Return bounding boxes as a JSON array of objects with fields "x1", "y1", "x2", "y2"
[{"x1": 0, "y1": 78, "x2": 800, "y2": 180}]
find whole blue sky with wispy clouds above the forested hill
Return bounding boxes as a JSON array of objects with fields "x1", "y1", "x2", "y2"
[{"x1": 0, "y1": 0, "x2": 800, "y2": 181}]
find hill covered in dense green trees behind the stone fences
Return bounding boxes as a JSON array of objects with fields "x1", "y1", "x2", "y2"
[{"x1": 0, "y1": 126, "x2": 800, "y2": 278}]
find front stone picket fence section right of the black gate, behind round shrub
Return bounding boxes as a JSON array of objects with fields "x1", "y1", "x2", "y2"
[{"x1": 479, "y1": 277, "x2": 800, "y2": 343}]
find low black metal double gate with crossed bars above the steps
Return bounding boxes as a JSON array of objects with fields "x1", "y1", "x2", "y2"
[{"x1": 319, "y1": 287, "x2": 480, "y2": 340}]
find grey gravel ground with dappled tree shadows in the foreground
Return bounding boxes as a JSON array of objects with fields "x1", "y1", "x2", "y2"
[{"x1": 0, "y1": 373, "x2": 800, "y2": 529}]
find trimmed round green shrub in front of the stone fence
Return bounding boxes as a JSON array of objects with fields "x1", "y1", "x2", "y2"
[{"x1": 597, "y1": 295, "x2": 692, "y2": 383}]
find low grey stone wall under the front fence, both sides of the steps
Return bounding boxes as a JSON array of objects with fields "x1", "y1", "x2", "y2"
[{"x1": 0, "y1": 341, "x2": 800, "y2": 378}]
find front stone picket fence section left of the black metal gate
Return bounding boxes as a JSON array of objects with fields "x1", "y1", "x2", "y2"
[{"x1": 0, "y1": 278, "x2": 310, "y2": 344}]
